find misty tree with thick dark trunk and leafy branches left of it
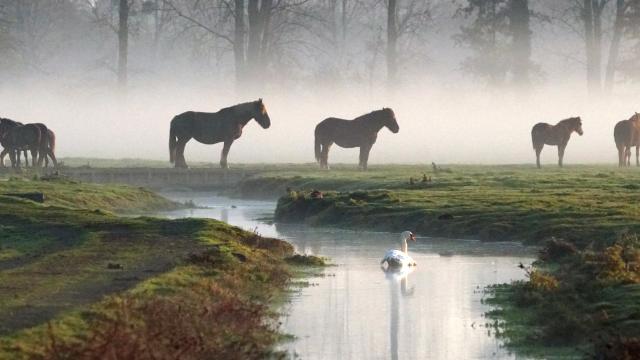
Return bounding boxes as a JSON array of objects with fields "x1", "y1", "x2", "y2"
[{"x1": 454, "y1": 0, "x2": 536, "y2": 87}]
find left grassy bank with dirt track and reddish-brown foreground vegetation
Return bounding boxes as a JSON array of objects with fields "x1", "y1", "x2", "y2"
[{"x1": 0, "y1": 179, "x2": 300, "y2": 359}]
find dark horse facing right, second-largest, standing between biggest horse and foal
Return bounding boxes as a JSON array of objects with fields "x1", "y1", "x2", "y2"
[{"x1": 315, "y1": 108, "x2": 400, "y2": 170}]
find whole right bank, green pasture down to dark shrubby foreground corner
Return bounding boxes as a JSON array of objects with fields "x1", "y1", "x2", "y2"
[{"x1": 239, "y1": 166, "x2": 640, "y2": 359}]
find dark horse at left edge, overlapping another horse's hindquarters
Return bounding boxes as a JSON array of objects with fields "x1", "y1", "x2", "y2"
[{"x1": 0, "y1": 124, "x2": 43, "y2": 168}]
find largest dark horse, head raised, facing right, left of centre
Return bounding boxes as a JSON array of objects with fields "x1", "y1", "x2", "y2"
[{"x1": 169, "y1": 99, "x2": 271, "y2": 169}]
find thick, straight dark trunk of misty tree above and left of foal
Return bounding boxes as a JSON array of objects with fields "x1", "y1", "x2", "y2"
[{"x1": 509, "y1": 0, "x2": 531, "y2": 87}]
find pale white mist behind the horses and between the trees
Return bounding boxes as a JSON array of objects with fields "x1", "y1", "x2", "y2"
[{"x1": 0, "y1": 1, "x2": 640, "y2": 165}]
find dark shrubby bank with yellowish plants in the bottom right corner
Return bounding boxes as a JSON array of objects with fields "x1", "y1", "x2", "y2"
[{"x1": 488, "y1": 236, "x2": 640, "y2": 359}]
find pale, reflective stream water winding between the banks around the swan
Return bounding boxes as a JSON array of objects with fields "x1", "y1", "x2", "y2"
[{"x1": 159, "y1": 194, "x2": 532, "y2": 359}]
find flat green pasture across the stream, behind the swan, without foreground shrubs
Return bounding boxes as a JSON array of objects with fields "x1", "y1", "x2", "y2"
[{"x1": 241, "y1": 166, "x2": 640, "y2": 245}]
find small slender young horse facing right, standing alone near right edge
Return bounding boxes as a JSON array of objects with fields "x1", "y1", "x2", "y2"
[{"x1": 531, "y1": 117, "x2": 583, "y2": 169}]
